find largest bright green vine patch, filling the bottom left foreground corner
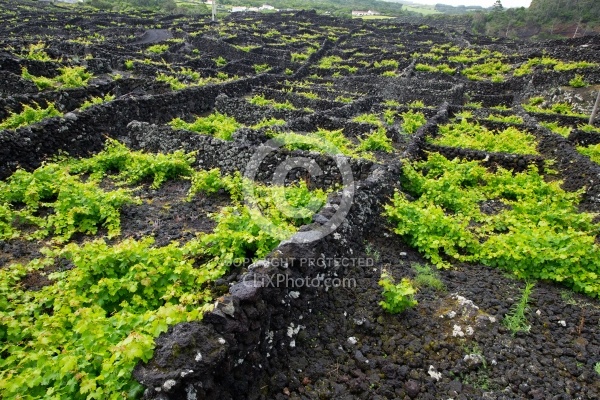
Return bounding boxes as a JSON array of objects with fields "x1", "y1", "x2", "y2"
[{"x1": 0, "y1": 239, "x2": 213, "y2": 399}]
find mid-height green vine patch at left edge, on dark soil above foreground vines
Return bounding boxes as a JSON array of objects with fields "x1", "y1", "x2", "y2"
[{"x1": 0, "y1": 164, "x2": 134, "y2": 241}]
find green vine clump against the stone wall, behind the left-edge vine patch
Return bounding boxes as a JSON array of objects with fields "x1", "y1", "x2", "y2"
[{"x1": 69, "y1": 139, "x2": 194, "y2": 189}]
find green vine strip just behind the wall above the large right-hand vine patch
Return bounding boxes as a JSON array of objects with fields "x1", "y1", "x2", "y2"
[{"x1": 429, "y1": 118, "x2": 537, "y2": 154}]
